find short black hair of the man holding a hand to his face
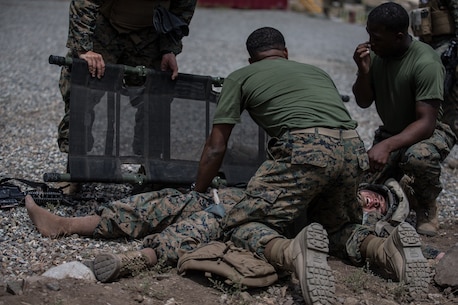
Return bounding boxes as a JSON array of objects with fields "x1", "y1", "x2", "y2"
[{"x1": 367, "y1": 2, "x2": 409, "y2": 33}]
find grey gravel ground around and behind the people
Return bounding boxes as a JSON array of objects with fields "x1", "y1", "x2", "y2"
[{"x1": 0, "y1": 0, "x2": 458, "y2": 282}]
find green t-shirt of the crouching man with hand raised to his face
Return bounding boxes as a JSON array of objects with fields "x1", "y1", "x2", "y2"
[{"x1": 371, "y1": 40, "x2": 444, "y2": 134}]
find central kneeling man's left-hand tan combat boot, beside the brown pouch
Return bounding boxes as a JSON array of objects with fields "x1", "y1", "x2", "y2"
[{"x1": 265, "y1": 223, "x2": 335, "y2": 305}]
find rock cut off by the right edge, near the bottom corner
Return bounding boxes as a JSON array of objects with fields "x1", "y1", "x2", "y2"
[{"x1": 434, "y1": 245, "x2": 458, "y2": 288}]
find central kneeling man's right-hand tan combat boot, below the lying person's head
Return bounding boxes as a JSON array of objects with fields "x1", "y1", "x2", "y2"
[{"x1": 361, "y1": 222, "x2": 430, "y2": 298}]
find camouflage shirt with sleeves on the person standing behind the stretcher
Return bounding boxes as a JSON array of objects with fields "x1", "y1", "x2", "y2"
[{"x1": 67, "y1": 0, "x2": 197, "y2": 54}]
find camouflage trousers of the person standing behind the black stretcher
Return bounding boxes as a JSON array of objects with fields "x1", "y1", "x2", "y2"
[{"x1": 57, "y1": 14, "x2": 162, "y2": 153}]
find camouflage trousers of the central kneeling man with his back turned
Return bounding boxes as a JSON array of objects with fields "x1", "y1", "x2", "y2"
[{"x1": 223, "y1": 132, "x2": 369, "y2": 257}]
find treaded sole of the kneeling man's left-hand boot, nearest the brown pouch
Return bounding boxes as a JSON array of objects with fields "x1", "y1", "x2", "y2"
[{"x1": 297, "y1": 223, "x2": 335, "y2": 305}]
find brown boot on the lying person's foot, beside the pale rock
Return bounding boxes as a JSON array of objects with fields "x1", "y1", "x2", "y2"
[{"x1": 93, "y1": 251, "x2": 151, "y2": 283}]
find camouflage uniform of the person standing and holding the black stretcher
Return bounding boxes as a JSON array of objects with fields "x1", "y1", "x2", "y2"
[{"x1": 57, "y1": 0, "x2": 197, "y2": 153}]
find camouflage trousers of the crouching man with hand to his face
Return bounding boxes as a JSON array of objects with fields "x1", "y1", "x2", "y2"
[{"x1": 366, "y1": 122, "x2": 456, "y2": 206}]
